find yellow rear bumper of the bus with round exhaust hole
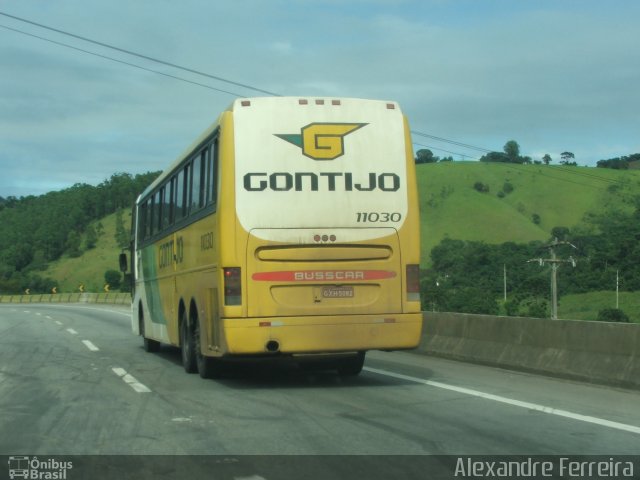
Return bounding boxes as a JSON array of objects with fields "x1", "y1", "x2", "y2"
[{"x1": 222, "y1": 313, "x2": 422, "y2": 355}]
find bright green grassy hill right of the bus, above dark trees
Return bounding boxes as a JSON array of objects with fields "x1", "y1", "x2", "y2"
[{"x1": 417, "y1": 162, "x2": 640, "y2": 267}]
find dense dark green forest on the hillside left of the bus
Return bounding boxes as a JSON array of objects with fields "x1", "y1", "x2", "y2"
[{"x1": 0, "y1": 172, "x2": 159, "y2": 293}]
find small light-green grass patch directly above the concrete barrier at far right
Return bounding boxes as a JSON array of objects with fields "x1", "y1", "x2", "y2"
[{"x1": 558, "y1": 291, "x2": 640, "y2": 323}]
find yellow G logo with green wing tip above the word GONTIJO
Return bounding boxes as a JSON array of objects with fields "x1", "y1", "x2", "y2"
[{"x1": 275, "y1": 123, "x2": 368, "y2": 160}]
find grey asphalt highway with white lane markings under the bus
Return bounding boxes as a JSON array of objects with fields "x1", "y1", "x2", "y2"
[{"x1": 0, "y1": 305, "x2": 640, "y2": 479}]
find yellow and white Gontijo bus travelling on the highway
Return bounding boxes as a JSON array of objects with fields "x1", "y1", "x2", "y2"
[{"x1": 120, "y1": 97, "x2": 422, "y2": 378}]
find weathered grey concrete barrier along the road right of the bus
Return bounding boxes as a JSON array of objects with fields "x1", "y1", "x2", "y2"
[{"x1": 418, "y1": 312, "x2": 640, "y2": 389}]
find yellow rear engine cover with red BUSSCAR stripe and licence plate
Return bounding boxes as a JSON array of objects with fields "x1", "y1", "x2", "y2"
[{"x1": 247, "y1": 228, "x2": 402, "y2": 319}]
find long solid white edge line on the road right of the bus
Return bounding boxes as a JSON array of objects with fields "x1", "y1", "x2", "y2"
[{"x1": 363, "y1": 367, "x2": 640, "y2": 435}]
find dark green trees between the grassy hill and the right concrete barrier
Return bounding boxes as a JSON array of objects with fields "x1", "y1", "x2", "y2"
[{"x1": 422, "y1": 196, "x2": 640, "y2": 317}]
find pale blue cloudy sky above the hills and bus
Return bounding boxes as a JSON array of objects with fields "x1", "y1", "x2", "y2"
[{"x1": 0, "y1": 0, "x2": 640, "y2": 198}]
